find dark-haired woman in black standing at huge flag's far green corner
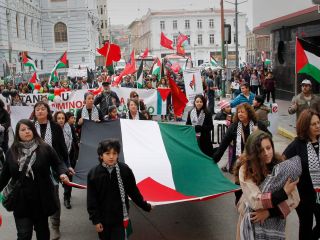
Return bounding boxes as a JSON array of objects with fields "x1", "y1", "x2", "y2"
[{"x1": 186, "y1": 94, "x2": 213, "y2": 157}]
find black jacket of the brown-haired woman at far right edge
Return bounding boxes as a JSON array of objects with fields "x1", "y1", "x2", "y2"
[{"x1": 283, "y1": 138, "x2": 316, "y2": 205}]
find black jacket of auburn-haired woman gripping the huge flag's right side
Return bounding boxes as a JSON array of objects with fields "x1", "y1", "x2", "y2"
[{"x1": 213, "y1": 121, "x2": 272, "y2": 163}]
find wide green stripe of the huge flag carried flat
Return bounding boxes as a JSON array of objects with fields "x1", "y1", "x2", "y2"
[{"x1": 159, "y1": 123, "x2": 239, "y2": 196}]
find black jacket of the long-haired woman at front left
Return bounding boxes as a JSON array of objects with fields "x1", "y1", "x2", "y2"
[{"x1": 0, "y1": 143, "x2": 67, "y2": 218}]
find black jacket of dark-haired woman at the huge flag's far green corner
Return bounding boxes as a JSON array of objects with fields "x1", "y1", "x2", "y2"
[{"x1": 186, "y1": 110, "x2": 213, "y2": 157}]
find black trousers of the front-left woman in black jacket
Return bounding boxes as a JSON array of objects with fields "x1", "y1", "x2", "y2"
[{"x1": 14, "y1": 217, "x2": 50, "y2": 240}]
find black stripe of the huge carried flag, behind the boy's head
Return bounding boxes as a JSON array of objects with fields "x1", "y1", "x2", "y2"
[{"x1": 73, "y1": 120, "x2": 124, "y2": 184}]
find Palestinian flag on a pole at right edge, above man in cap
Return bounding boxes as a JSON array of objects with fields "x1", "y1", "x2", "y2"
[{"x1": 296, "y1": 38, "x2": 320, "y2": 83}]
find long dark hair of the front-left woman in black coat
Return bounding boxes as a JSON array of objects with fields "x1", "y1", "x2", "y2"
[{"x1": 11, "y1": 119, "x2": 44, "y2": 156}]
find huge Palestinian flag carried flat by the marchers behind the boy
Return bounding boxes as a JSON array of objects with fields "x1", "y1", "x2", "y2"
[{"x1": 75, "y1": 119, "x2": 239, "y2": 204}]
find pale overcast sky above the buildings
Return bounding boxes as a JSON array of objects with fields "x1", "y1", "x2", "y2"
[{"x1": 108, "y1": 0, "x2": 253, "y2": 29}]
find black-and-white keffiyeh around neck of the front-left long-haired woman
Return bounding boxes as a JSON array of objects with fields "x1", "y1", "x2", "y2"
[{"x1": 18, "y1": 140, "x2": 38, "y2": 179}]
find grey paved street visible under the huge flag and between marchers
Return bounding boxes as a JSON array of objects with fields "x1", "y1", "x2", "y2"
[{"x1": 0, "y1": 101, "x2": 298, "y2": 240}]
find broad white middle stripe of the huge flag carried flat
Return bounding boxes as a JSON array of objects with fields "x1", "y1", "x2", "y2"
[{"x1": 120, "y1": 119, "x2": 175, "y2": 189}]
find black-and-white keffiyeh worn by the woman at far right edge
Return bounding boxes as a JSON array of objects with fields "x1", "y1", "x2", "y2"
[{"x1": 307, "y1": 138, "x2": 320, "y2": 203}]
